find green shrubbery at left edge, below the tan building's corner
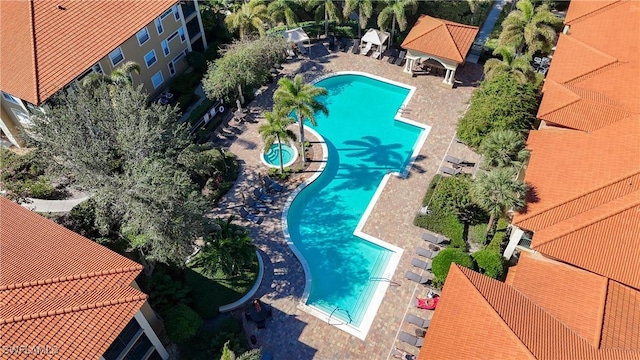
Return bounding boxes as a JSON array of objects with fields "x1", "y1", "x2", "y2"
[{"x1": 0, "y1": 148, "x2": 58, "y2": 199}]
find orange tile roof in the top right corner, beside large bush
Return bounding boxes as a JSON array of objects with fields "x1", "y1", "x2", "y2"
[{"x1": 538, "y1": 0, "x2": 640, "y2": 132}]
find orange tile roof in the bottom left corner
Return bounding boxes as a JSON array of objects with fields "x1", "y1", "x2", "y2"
[{"x1": 0, "y1": 197, "x2": 146, "y2": 359}]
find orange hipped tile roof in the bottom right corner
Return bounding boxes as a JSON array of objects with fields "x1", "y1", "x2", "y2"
[{"x1": 418, "y1": 260, "x2": 640, "y2": 360}]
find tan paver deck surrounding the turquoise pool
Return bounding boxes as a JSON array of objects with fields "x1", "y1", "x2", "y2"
[{"x1": 211, "y1": 44, "x2": 482, "y2": 359}]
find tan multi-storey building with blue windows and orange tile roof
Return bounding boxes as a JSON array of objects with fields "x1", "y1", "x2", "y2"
[{"x1": 0, "y1": 0, "x2": 207, "y2": 147}]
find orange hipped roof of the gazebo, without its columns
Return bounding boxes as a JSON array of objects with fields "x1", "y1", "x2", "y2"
[{"x1": 401, "y1": 15, "x2": 478, "y2": 63}]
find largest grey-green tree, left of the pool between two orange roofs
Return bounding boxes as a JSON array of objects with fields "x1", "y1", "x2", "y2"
[{"x1": 30, "y1": 82, "x2": 207, "y2": 265}]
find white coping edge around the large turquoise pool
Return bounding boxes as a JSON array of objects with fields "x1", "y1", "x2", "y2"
[{"x1": 280, "y1": 71, "x2": 431, "y2": 340}]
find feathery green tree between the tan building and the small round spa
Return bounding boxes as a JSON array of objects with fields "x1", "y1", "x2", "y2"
[{"x1": 202, "y1": 36, "x2": 288, "y2": 102}]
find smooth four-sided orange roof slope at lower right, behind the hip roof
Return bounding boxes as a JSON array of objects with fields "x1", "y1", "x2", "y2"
[{"x1": 512, "y1": 252, "x2": 608, "y2": 347}]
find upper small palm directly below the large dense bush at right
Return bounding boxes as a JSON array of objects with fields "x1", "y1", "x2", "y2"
[{"x1": 479, "y1": 130, "x2": 530, "y2": 170}]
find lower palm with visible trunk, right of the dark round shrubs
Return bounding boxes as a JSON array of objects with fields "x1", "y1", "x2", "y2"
[{"x1": 471, "y1": 168, "x2": 527, "y2": 236}]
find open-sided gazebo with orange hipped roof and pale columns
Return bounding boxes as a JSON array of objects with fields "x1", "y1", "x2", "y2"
[{"x1": 401, "y1": 15, "x2": 479, "y2": 86}]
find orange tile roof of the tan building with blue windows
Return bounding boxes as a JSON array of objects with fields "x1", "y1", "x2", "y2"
[{"x1": 0, "y1": 0, "x2": 177, "y2": 104}]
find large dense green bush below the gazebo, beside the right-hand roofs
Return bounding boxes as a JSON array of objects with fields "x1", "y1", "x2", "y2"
[{"x1": 458, "y1": 74, "x2": 538, "y2": 149}]
